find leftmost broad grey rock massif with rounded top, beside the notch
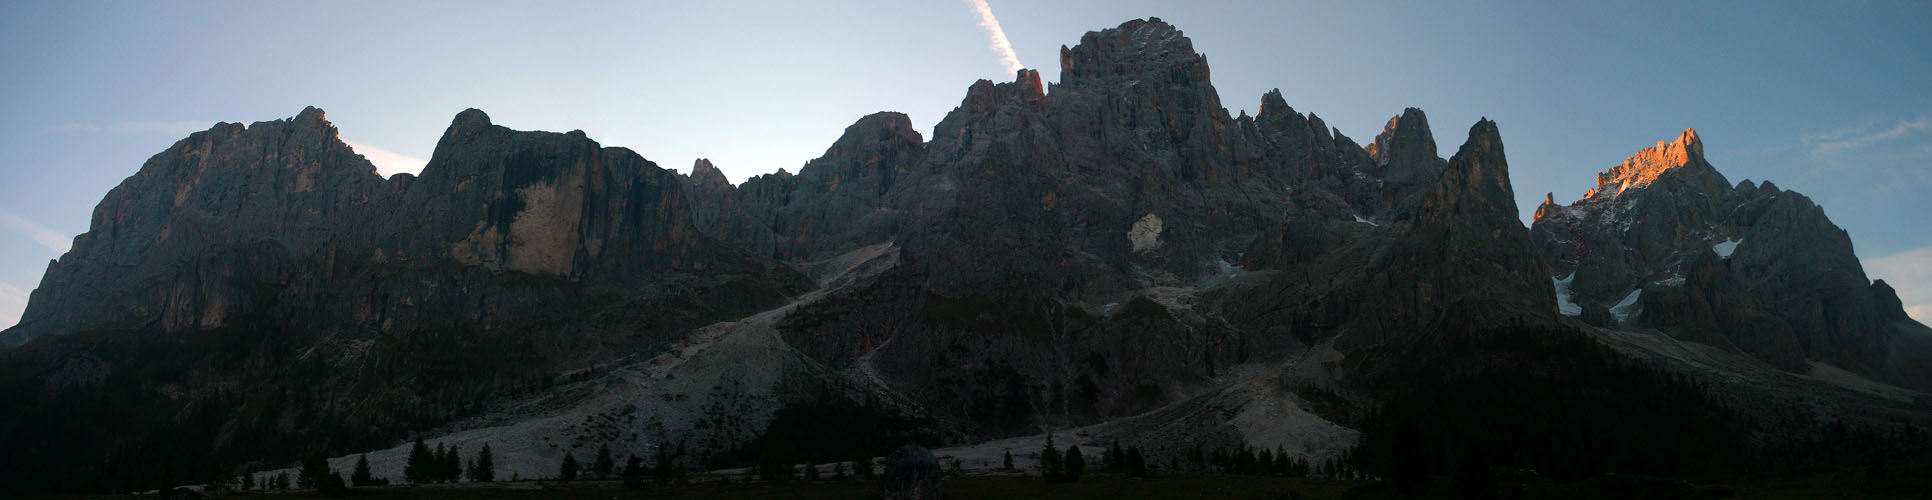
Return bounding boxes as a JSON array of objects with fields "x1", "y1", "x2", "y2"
[{"x1": 0, "y1": 108, "x2": 388, "y2": 344}]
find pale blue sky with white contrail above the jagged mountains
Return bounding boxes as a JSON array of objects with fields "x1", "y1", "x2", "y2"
[{"x1": 0, "y1": 0, "x2": 1932, "y2": 326}]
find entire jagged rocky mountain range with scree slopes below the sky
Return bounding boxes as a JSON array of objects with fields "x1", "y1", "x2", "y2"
[{"x1": 0, "y1": 17, "x2": 1932, "y2": 498}]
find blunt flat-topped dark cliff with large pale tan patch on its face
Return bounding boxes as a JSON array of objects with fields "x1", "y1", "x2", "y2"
[{"x1": 398, "y1": 110, "x2": 726, "y2": 282}]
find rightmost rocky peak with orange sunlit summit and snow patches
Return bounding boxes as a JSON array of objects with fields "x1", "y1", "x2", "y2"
[{"x1": 1532, "y1": 129, "x2": 1932, "y2": 388}]
